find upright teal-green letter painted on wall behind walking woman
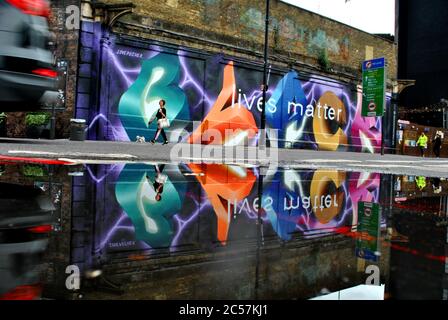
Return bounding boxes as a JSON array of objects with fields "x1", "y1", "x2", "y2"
[{"x1": 118, "y1": 53, "x2": 189, "y2": 140}]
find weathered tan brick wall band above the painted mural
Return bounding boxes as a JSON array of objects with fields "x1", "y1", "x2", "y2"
[{"x1": 103, "y1": 0, "x2": 397, "y2": 79}]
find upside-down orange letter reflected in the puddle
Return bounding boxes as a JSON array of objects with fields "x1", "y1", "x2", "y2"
[{"x1": 188, "y1": 164, "x2": 256, "y2": 245}]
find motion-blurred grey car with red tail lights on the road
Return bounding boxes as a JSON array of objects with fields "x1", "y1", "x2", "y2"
[{"x1": 0, "y1": 0, "x2": 57, "y2": 111}]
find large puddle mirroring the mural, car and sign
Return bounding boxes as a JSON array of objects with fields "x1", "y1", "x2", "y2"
[{"x1": 0, "y1": 162, "x2": 448, "y2": 300}]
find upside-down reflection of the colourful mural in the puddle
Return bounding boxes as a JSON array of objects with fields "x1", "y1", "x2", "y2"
[{"x1": 93, "y1": 164, "x2": 380, "y2": 251}]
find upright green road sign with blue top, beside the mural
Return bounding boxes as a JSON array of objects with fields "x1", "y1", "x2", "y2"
[{"x1": 361, "y1": 58, "x2": 387, "y2": 117}]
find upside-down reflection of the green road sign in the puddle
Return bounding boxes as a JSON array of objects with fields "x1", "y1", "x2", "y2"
[{"x1": 356, "y1": 202, "x2": 381, "y2": 262}]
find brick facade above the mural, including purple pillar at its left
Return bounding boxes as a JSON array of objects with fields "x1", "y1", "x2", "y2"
[{"x1": 8, "y1": 0, "x2": 397, "y2": 145}]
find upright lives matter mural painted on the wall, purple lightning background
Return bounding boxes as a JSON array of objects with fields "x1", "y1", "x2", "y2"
[{"x1": 91, "y1": 37, "x2": 388, "y2": 152}]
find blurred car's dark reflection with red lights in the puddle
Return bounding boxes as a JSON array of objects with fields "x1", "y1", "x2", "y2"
[{"x1": 0, "y1": 183, "x2": 54, "y2": 300}]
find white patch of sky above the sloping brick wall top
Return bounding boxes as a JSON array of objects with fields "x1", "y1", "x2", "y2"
[{"x1": 282, "y1": 0, "x2": 395, "y2": 35}]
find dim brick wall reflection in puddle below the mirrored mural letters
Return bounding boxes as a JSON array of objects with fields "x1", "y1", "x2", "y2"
[{"x1": 85, "y1": 237, "x2": 389, "y2": 300}]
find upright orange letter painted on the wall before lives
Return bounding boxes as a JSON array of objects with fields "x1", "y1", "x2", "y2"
[{"x1": 188, "y1": 62, "x2": 258, "y2": 144}]
